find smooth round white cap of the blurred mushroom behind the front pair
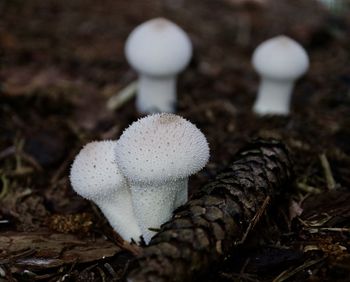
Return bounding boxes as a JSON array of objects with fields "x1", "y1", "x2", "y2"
[{"x1": 125, "y1": 18, "x2": 192, "y2": 76}]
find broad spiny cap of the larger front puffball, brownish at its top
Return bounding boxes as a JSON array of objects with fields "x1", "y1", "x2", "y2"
[{"x1": 115, "y1": 113, "x2": 209, "y2": 184}]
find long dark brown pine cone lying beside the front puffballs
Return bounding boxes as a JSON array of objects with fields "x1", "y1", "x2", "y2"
[{"x1": 128, "y1": 140, "x2": 292, "y2": 282}]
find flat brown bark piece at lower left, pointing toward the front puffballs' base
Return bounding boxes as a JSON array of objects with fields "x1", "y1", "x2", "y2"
[{"x1": 0, "y1": 232, "x2": 122, "y2": 270}]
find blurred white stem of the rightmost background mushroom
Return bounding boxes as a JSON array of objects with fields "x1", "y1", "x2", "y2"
[{"x1": 253, "y1": 78, "x2": 294, "y2": 115}]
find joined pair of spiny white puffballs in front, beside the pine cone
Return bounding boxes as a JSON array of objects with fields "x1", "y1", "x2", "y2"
[{"x1": 70, "y1": 113, "x2": 209, "y2": 243}]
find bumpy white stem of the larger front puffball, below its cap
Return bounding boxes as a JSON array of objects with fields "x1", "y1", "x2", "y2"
[{"x1": 131, "y1": 178, "x2": 188, "y2": 244}]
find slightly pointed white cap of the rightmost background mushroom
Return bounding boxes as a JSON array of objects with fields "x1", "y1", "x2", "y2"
[{"x1": 252, "y1": 35, "x2": 309, "y2": 80}]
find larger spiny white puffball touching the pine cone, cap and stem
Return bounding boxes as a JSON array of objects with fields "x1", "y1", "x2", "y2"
[{"x1": 115, "y1": 113, "x2": 209, "y2": 243}]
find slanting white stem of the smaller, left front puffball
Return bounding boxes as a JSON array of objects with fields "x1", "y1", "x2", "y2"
[{"x1": 96, "y1": 187, "x2": 141, "y2": 242}]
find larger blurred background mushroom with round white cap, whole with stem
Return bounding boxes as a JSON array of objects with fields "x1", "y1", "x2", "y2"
[{"x1": 125, "y1": 18, "x2": 192, "y2": 113}]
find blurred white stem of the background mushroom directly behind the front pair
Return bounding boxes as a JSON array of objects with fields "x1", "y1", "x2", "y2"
[{"x1": 136, "y1": 75, "x2": 176, "y2": 113}]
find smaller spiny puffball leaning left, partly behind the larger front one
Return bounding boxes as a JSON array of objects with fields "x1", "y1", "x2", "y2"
[{"x1": 70, "y1": 141, "x2": 141, "y2": 241}]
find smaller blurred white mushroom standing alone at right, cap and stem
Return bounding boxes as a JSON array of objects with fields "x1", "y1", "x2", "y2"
[{"x1": 252, "y1": 35, "x2": 309, "y2": 115}]
